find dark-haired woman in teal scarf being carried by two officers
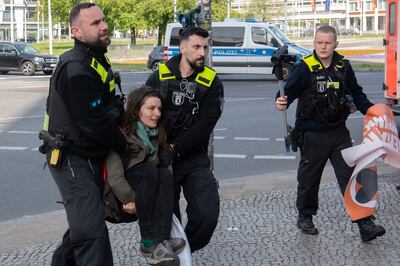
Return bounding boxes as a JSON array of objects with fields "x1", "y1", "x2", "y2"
[{"x1": 106, "y1": 86, "x2": 186, "y2": 265}]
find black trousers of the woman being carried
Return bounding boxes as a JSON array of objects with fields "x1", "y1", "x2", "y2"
[{"x1": 125, "y1": 162, "x2": 174, "y2": 243}]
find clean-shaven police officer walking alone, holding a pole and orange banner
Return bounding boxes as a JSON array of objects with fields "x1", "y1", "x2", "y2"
[{"x1": 276, "y1": 25, "x2": 386, "y2": 242}]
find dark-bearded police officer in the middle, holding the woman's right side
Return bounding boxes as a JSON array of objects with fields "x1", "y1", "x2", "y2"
[{"x1": 146, "y1": 28, "x2": 223, "y2": 252}]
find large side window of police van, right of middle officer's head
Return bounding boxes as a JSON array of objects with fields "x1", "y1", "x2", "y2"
[{"x1": 212, "y1": 27, "x2": 244, "y2": 47}]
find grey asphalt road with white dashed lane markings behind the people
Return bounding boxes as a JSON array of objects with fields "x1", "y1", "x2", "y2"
[{"x1": 0, "y1": 72, "x2": 384, "y2": 221}]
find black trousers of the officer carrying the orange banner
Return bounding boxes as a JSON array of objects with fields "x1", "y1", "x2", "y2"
[{"x1": 296, "y1": 125, "x2": 353, "y2": 215}]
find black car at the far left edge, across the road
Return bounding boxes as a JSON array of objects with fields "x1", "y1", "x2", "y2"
[{"x1": 0, "y1": 42, "x2": 58, "y2": 76}]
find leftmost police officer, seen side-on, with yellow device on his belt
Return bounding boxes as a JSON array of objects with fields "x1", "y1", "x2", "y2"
[{"x1": 40, "y1": 3, "x2": 127, "y2": 266}]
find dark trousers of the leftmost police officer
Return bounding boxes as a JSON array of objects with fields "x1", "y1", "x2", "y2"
[{"x1": 49, "y1": 156, "x2": 113, "y2": 266}]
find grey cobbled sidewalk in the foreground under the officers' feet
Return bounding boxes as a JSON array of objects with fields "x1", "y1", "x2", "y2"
[{"x1": 0, "y1": 165, "x2": 400, "y2": 266}]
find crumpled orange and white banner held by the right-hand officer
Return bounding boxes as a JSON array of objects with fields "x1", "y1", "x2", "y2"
[{"x1": 342, "y1": 104, "x2": 400, "y2": 221}]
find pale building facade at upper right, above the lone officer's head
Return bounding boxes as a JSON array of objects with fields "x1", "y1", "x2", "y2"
[{"x1": 231, "y1": 0, "x2": 386, "y2": 35}]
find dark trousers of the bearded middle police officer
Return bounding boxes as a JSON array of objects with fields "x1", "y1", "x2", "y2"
[{"x1": 173, "y1": 152, "x2": 219, "y2": 252}]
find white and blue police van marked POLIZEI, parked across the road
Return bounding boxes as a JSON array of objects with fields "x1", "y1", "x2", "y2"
[{"x1": 164, "y1": 21, "x2": 311, "y2": 79}]
